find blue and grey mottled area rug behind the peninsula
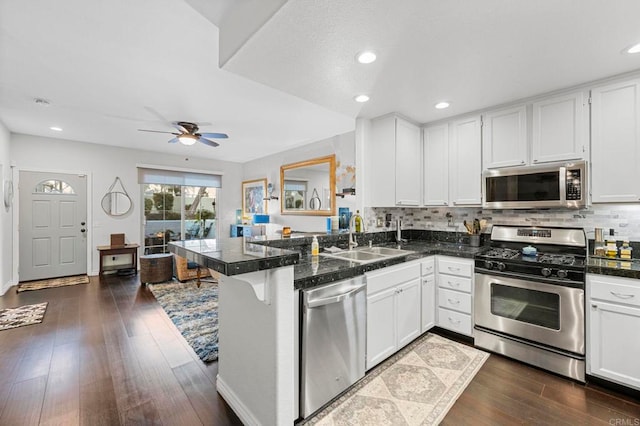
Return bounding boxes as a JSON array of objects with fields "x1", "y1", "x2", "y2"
[{"x1": 147, "y1": 280, "x2": 218, "y2": 362}]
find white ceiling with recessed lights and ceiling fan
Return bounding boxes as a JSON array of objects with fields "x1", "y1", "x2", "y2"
[{"x1": 0, "y1": 0, "x2": 640, "y2": 162}]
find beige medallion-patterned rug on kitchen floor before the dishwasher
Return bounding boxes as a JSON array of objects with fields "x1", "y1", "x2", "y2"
[{"x1": 306, "y1": 334, "x2": 489, "y2": 426}]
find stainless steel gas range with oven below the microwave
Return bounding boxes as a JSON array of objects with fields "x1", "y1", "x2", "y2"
[{"x1": 474, "y1": 225, "x2": 587, "y2": 382}]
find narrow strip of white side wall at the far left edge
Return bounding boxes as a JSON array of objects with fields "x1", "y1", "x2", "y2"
[{"x1": 0, "y1": 121, "x2": 13, "y2": 295}]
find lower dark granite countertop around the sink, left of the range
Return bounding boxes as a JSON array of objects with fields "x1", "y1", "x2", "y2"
[{"x1": 294, "y1": 240, "x2": 482, "y2": 290}]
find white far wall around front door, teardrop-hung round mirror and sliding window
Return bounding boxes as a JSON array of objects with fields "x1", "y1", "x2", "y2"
[{"x1": 12, "y1": 134, "x2": 242, "y2": 275}]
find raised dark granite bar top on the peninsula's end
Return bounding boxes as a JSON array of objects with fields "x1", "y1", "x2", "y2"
[{"x1": 169, "y1": 238, "x2": 300, "y2": 276}]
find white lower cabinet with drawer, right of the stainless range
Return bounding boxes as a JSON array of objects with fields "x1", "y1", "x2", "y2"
[{"x1": 587, "y1": 274, "x2": 640, "y2": 389}]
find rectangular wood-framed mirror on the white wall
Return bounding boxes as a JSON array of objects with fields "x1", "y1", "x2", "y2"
[{"x1": 280, "y1": 154, "x2": 336, "y2": 216}]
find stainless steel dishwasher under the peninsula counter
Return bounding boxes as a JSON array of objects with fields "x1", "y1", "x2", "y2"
[{"x1": 300, "y1": 277, "x2": 367, "y2": 418}]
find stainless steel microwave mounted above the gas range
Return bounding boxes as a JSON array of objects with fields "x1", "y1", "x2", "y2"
[{"x1": 482, "y1": 161, "x2": 588, "y2": 209}]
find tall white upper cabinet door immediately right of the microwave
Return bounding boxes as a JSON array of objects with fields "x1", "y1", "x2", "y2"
[{"x1": 591, "y1": 79, "x2": 640, "y2": 203}]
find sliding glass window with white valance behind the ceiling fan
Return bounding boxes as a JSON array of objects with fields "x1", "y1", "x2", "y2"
[{"x1": 138, "y1": 168, "x2": 221, "y2": 254}]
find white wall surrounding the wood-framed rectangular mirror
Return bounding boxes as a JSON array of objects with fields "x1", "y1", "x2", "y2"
[{"x1": 238, "y1": 132, "x2": 356, "y2": 234}]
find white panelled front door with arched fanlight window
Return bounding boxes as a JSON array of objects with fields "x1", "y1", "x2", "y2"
[{"x1": 18, "y1": 171, "x2": 87, "y2": 281}]
